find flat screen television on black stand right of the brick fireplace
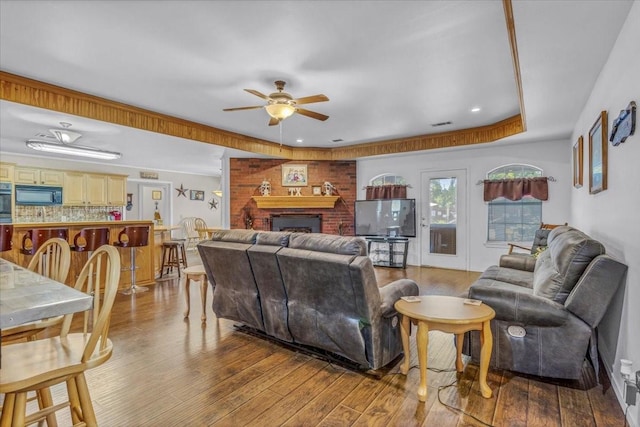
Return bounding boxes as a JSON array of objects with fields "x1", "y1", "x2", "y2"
[{"x1": 354, "y1": 199, "x2": 416, "y2": 237}]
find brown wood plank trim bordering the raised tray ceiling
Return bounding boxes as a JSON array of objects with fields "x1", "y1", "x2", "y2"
[{"x1": 0, "y1": 0, "x2": 526, "y2": 160}]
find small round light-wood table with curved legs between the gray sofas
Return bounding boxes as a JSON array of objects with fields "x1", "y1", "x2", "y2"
[{"x1": 394, "y1": 295, "x2": 496, "y2": 402}]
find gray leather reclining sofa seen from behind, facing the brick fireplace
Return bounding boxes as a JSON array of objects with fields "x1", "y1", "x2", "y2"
[{"x1": 198, "y1": 230, "x2": 418, "y2": 369}]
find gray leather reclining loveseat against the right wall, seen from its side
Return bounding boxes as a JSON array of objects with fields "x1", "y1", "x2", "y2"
[{"x1": 465, "y1": 226, "x2": 627, "y2": 379}]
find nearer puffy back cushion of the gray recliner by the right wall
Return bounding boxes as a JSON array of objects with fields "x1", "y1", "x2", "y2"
[{"x1": 533, "y1": 226, "x2": 605, "y2": 304}]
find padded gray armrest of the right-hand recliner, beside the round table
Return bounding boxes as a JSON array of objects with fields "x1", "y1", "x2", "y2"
[{"x1": 469, "y1": 286, "x2": 573, "y2": 327}]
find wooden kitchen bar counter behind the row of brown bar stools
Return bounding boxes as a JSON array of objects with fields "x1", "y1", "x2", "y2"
[{"x1": 0, "y1": 220, "x2": 159, "y2": 289}]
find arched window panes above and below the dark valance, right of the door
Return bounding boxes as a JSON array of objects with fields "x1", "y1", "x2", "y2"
[{"x1": 487, "y1": 164, "x2": 542, "y2": 242}]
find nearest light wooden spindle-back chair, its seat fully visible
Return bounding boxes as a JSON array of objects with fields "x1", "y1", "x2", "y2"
[{"x1": 0, "y1": 245, "x2": 120, "y2": 426}]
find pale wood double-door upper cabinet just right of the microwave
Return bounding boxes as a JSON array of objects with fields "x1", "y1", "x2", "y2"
[{"x1": 62, "y1": 172, "x2": 107, "y2": 206}]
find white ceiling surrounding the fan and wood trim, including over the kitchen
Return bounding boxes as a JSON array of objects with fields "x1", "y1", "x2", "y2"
[{"x1": 0, "y1": 0, "x2": 640, "y2": 175}]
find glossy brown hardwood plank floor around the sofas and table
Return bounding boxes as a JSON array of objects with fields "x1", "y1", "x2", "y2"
[{"x1": 15, "y1": 260, "x2": 624, "y2": 426}]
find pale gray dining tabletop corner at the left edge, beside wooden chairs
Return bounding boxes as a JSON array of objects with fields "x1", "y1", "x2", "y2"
[{"x1": 0, "y1": 258, "x2": 93, "y2": 329}]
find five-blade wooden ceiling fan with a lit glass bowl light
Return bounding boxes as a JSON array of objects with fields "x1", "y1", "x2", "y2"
[{"x1": 223, "y1": 80, "x2": 329, "y2": 126}]
